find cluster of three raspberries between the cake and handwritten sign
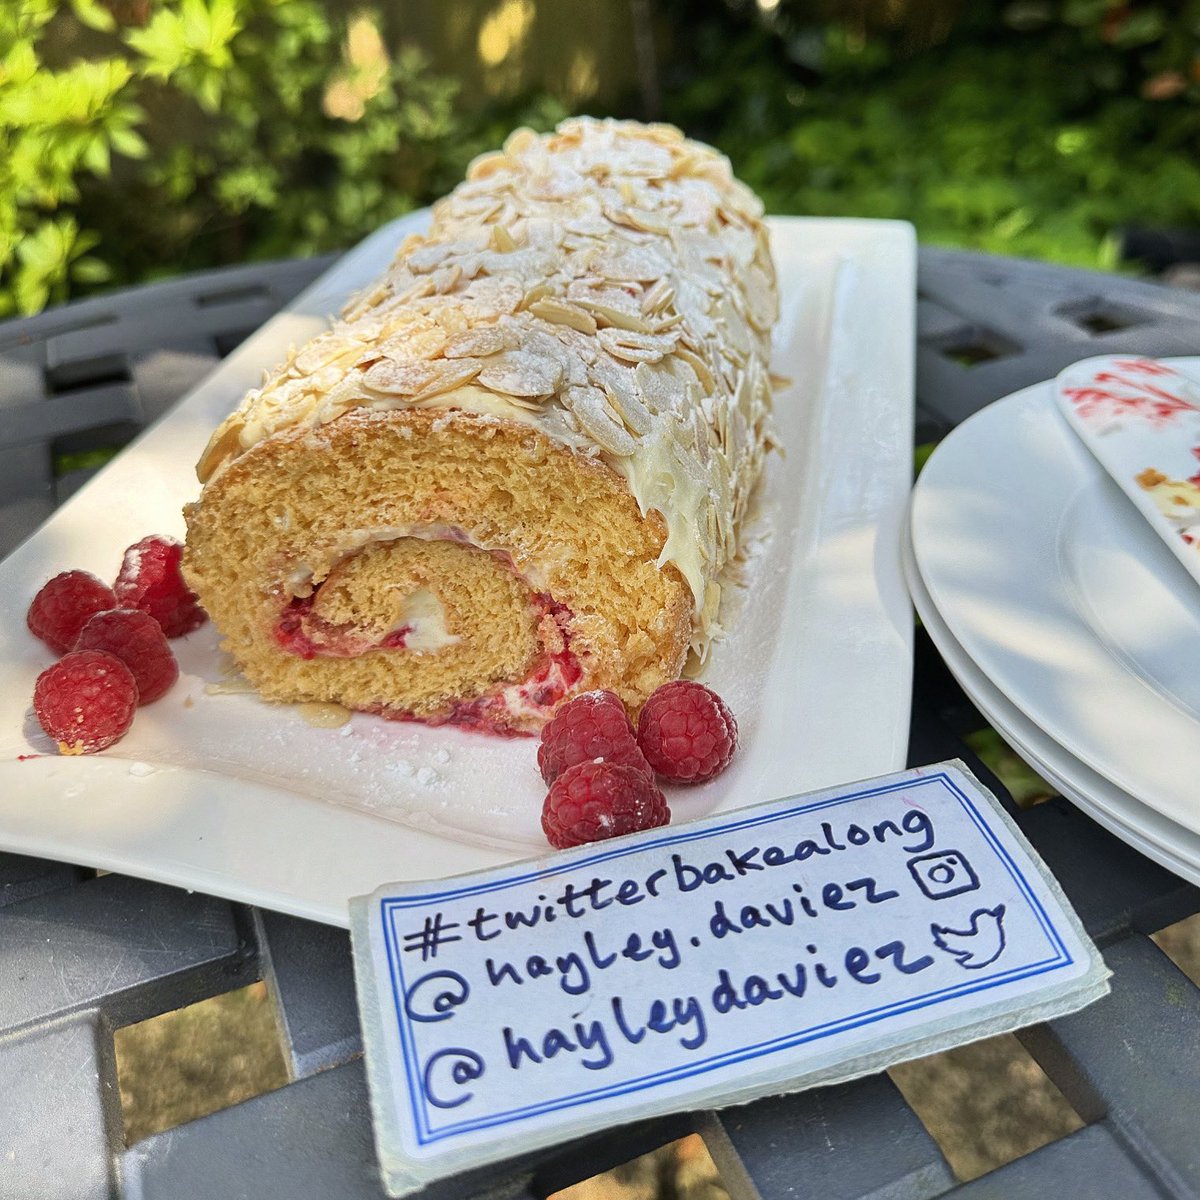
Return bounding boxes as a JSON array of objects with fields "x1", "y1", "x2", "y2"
[{"x1": 538, "y1": 679, "x2": 738, "y2": 850}]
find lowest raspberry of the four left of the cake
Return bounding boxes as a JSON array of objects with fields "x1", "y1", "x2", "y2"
[{"x1": 34, "y1": 650, "x2": 138, "y2": 754}]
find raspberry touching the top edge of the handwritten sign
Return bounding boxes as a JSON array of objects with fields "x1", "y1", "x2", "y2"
[{"x1": 541, "y1": 762, "x2": 671, "y2": 850}]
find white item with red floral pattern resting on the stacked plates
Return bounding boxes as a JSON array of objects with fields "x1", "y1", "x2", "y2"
[{"x1": 1055, "y1": 356, "x2": 1200, "y2": 582}]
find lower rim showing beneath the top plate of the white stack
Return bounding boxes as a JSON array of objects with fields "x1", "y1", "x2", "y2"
[{"x1": 901, "y1": 520, "x2": 1200, "y2": 884}]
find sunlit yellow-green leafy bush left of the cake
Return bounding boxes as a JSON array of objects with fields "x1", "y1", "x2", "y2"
[{"x1": 0, "y1": 0, "x2": 475, "y2": 314}]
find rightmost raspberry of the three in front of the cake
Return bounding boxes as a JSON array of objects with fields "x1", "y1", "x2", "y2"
[{"x1": 637, "y1": 679, "x2": 738, "y2": 784}]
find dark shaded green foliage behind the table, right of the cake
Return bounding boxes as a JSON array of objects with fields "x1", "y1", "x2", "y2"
[{"x1": 667, "y1": 0, "x2": 1200, "y2": 268}]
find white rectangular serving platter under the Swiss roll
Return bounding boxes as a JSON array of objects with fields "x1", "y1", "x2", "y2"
[{"x1": 0, "y1": 214, "x2": 916, "y2": 924}]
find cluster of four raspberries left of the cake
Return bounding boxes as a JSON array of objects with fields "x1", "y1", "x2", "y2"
[{"x1": 25, "y1": 536, "x2": 205, "y2": 754}]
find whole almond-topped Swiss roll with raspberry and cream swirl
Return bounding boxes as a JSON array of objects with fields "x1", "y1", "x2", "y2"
[{"x1": 185, "y1": 119, "x2": 778, "y2": 733}]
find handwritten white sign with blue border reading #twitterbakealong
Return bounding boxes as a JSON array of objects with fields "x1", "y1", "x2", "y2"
[{"x1": 352, "y1": 763, "x2": 1108, "y2": 1195}]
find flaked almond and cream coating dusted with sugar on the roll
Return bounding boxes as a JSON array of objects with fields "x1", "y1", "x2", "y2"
[{"x1": 198, "y1": 119, "x2": 778, "y2": 649}]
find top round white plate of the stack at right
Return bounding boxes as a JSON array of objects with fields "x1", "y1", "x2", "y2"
[{"x1": 912, "y1": 359, "x2": 1200, "y2": 834}]
